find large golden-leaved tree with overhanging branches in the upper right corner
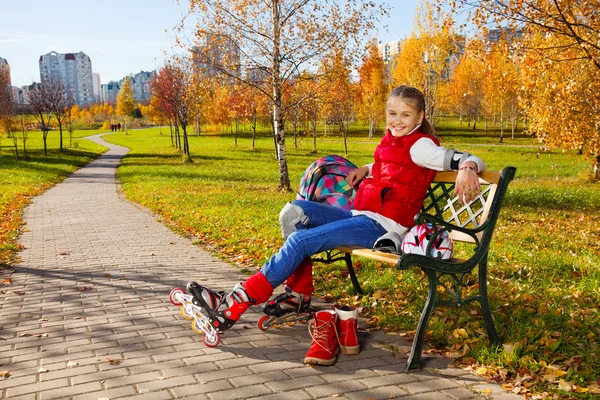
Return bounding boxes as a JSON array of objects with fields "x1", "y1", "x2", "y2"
[{"x1": 449, "y1": 0, "x2": 600, "y2": 181}]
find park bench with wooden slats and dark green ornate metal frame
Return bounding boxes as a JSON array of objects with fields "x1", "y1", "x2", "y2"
[{"x1": 315, "y1": 167, "x2": 516, "y2": 372}]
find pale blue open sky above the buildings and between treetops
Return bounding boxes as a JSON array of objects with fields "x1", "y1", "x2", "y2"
[{"x1": 0, "y1": 0, "x2": 419, "y2": 86}]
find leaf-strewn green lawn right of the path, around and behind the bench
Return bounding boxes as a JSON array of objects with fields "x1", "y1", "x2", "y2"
[{"x1": 0, "y1": 124, "x2": 600, "y2": 398}]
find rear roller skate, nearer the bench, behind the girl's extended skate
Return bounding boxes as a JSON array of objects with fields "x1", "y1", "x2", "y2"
[{"x1": 258, "y1": 287, "x2": 314, "y2": 331}]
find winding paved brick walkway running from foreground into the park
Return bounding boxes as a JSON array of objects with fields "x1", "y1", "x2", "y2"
[{"x1": 0, "y1": 135, "x2": 520, "y2": 400}]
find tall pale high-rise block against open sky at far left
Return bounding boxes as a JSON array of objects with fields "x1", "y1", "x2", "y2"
[{"x1": 40, "y1": 51, "x2": 94, "y2": 105}]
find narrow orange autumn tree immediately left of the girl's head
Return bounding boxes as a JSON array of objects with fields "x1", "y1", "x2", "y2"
[{"x1": 355, "y1": 41, "x2": 388, "y2": 139}]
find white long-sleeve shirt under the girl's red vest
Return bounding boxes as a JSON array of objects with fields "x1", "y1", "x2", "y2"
[{"x1": 352, "y1": 138, "x2": 485, "y2": 237}]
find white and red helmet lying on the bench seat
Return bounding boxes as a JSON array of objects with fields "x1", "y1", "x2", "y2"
[{"x1": 402, "y1": 223, "x2": 454, "y2": 260}]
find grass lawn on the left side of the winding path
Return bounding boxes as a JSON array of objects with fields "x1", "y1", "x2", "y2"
[{"x1": 0, "y1": 131, "x2": 106, "y2": 268}]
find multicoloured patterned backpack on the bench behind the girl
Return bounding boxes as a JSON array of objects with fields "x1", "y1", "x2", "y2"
[{"x1": 296, "y1": 155, "x2": 357, "y2": 210}]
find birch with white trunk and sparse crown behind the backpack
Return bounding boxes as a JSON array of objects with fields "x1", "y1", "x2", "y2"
[{"x1": 180, "y1": 0, "x2": 385, "y2": 190}]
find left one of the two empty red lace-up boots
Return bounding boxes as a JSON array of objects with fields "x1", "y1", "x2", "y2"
[{"x1": 304, "y1": 310, "x2": 340, "y2": 365}]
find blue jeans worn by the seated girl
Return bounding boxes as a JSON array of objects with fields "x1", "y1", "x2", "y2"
[{"x1": 261, "y1": 200, "x2": 386, "y2": 288}]
